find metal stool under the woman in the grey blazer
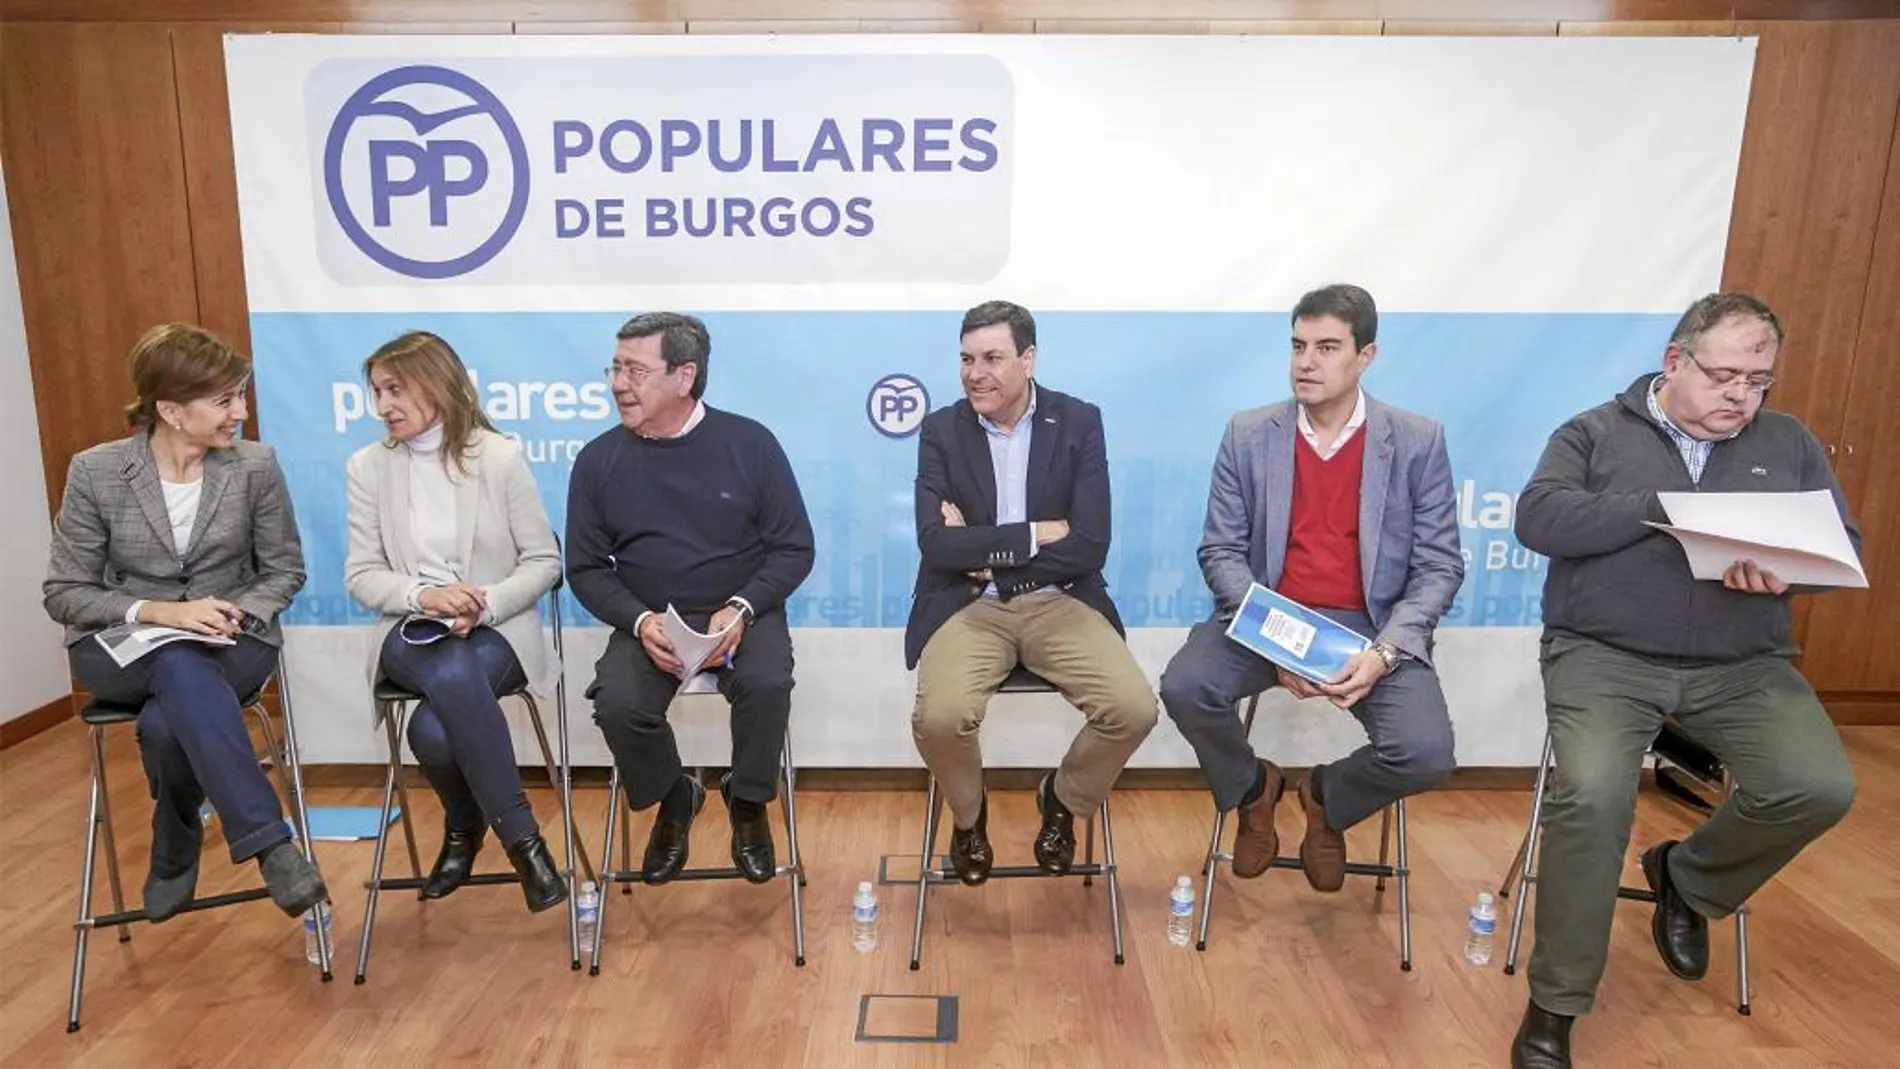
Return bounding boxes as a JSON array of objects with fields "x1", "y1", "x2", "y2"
[{"x1": 67, "y1": 659, "x2": 333, "y2": 1033}]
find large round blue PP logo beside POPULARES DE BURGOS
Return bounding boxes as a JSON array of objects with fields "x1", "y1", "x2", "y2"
[{"x1": 323, "y1": 65, "x2": 528, "y2": 279}]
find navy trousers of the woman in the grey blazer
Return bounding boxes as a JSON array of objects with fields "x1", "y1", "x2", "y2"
[{"x1": 67, "y1": 634, "x2": 291, "y2": 877}]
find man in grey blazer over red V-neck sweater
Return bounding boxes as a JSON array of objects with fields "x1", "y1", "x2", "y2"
[{"x1": 1161, "y1": 285, "x2": 1465, "y2": 891}]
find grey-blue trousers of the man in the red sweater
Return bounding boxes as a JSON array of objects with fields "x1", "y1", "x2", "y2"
[{"x1": 1161, "y1": 610, "x2": 1454, "y2": 832}]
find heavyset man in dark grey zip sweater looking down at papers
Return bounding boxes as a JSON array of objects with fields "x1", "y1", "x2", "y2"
[{"x1": 1512, "y1": 294, "x2": 1860, "y2": 1069}]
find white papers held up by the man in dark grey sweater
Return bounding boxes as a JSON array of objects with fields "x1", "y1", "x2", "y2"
[{"x1": 1644, "y1": 490, "x2": 1868, "y2": 587}]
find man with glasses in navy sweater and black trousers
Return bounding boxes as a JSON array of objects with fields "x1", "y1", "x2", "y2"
[{"x1": 566, "y1": 311, "x2": 813, "y2": 883}]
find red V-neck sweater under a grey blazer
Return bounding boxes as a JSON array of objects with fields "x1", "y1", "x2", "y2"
[{"x1": 1279, "y1": 427, "x2": 1366, "y2": 611}]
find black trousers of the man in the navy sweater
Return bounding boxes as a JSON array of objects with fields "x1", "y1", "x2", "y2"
[{"x1": 587, "y1": 611, "x2": 792, "y2": 809}]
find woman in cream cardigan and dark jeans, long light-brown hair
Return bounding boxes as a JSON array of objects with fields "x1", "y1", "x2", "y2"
[{"x1": 344, "y1": 330, "x2": 568, "y2": 911}]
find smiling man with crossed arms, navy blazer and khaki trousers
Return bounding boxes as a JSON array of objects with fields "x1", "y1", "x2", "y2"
[{"x1": 904, "y1": 300, "x2": 1155, "y2": 885}]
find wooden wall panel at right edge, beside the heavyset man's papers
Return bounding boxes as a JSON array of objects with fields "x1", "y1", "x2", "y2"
[{"x1": 1801, "y1": 108, "x2": 1900, "y2": 703}]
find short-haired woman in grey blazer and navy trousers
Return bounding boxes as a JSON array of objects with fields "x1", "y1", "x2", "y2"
[{"x1": 42, "y1": 323, "x2": 327, "y2": 921}]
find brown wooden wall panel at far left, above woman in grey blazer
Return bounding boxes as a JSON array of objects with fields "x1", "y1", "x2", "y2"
[{"x1": 0, "y1": 23, "x2": 198, "y2": 509}]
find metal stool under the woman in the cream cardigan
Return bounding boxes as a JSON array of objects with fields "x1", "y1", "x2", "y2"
[{"x1": 355, "y1": 579, "x2": 595, "y2": 984}]
